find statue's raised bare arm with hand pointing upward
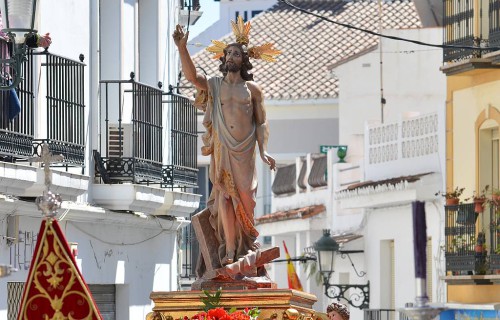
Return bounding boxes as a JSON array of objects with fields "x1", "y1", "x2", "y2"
[{"x1": 172, "y1": 25, "x2": 208, "y2": 90}]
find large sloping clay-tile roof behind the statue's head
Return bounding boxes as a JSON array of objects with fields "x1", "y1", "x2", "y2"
[{"x1": 183, "y1": 0, "x2": 421, "y2": 100}]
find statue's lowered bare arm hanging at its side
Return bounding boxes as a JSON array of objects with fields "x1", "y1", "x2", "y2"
[{"x1": 247, "y1": 81, "x2": 276, "y2": 170}]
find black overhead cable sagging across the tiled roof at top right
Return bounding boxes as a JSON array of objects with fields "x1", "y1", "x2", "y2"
[{"x1": 278, "y1": 0, "x2": 500, "y2": 51}]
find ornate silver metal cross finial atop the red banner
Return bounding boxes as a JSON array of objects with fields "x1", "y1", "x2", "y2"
[{"x1": 30, "y1": 143, "x2": 64, "y2": 218}]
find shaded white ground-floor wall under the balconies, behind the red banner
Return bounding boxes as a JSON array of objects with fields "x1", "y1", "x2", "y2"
[{"x1": 0, "y1": 212, "x2": 177, "y2": 319}]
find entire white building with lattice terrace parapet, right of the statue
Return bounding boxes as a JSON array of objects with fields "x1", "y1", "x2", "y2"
[{"x1": 258, "y1": 28, "x2": 445, "y2": 319}]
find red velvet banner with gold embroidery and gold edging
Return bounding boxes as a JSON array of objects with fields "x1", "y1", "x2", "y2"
[{"x1": 17, "y1": 219, "x2": 102, "y2": 320}]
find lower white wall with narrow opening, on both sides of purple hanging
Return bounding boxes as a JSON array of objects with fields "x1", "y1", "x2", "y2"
[{"x1": 364, "y1": 201, "x2": 444, "y2": 309}]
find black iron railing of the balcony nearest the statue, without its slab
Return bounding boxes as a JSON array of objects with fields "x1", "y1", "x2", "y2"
[{"x1": 94, "y1": 74, "x2": 198, "y2": 188}]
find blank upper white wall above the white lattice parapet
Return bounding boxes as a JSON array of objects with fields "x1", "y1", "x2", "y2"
[{"x1": 334, "y1": 28, "x2": 446, "y2": 144}]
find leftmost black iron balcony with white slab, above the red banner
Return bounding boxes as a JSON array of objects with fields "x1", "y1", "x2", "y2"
[{"x1": 0, "y1": 39, "x2": 88, "y2": 199}]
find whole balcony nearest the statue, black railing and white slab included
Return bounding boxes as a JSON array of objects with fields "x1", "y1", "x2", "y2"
[{"x1": 93, "y1": 73, "x2": 199, "y2": 216}]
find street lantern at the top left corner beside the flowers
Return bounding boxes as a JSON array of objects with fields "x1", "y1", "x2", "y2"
[{"x1": 0, "y1": 0, "x2": 38, "y2": 90}]
